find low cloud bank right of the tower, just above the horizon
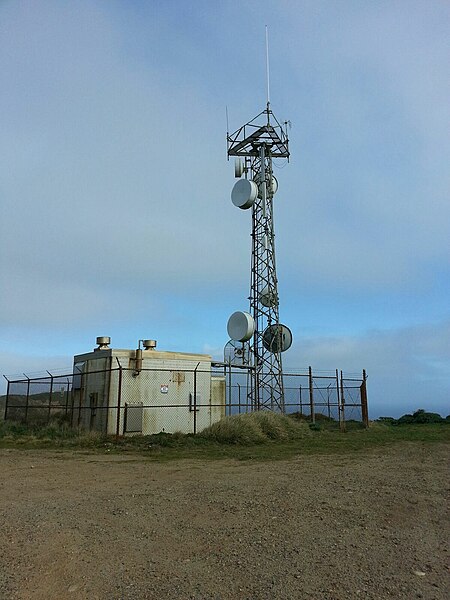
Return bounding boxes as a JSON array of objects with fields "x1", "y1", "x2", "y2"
[{"x1": 284, "y1": 321, "x2": 450, "y2": 418}]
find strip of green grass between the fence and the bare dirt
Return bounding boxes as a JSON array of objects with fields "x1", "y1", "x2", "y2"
[{"x1": 0, "y1": 411, "x2": 450, "y2": 461}]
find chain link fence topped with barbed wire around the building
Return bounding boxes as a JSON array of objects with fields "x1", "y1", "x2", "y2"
[{"x1": 4, "y1": 363, "x2": 368, "y2": 435}]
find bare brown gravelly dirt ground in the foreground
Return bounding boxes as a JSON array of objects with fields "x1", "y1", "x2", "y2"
[{"x1": 0, "y1": 443, "x2": 450, "y2": 600}]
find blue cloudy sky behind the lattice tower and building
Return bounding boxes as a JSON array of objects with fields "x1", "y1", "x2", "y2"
[{"x1": 0, "y1": 0, "x2": 450, "y2": 417}]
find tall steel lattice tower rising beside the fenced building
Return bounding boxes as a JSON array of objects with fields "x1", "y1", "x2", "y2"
[{"x1": 227, "y1": 102, "x2": 292, "y2": 412}]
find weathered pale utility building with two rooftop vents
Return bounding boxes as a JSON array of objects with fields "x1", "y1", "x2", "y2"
[{"x1": 72, "y1": 338, "x2": 225, "y2": 435}]
